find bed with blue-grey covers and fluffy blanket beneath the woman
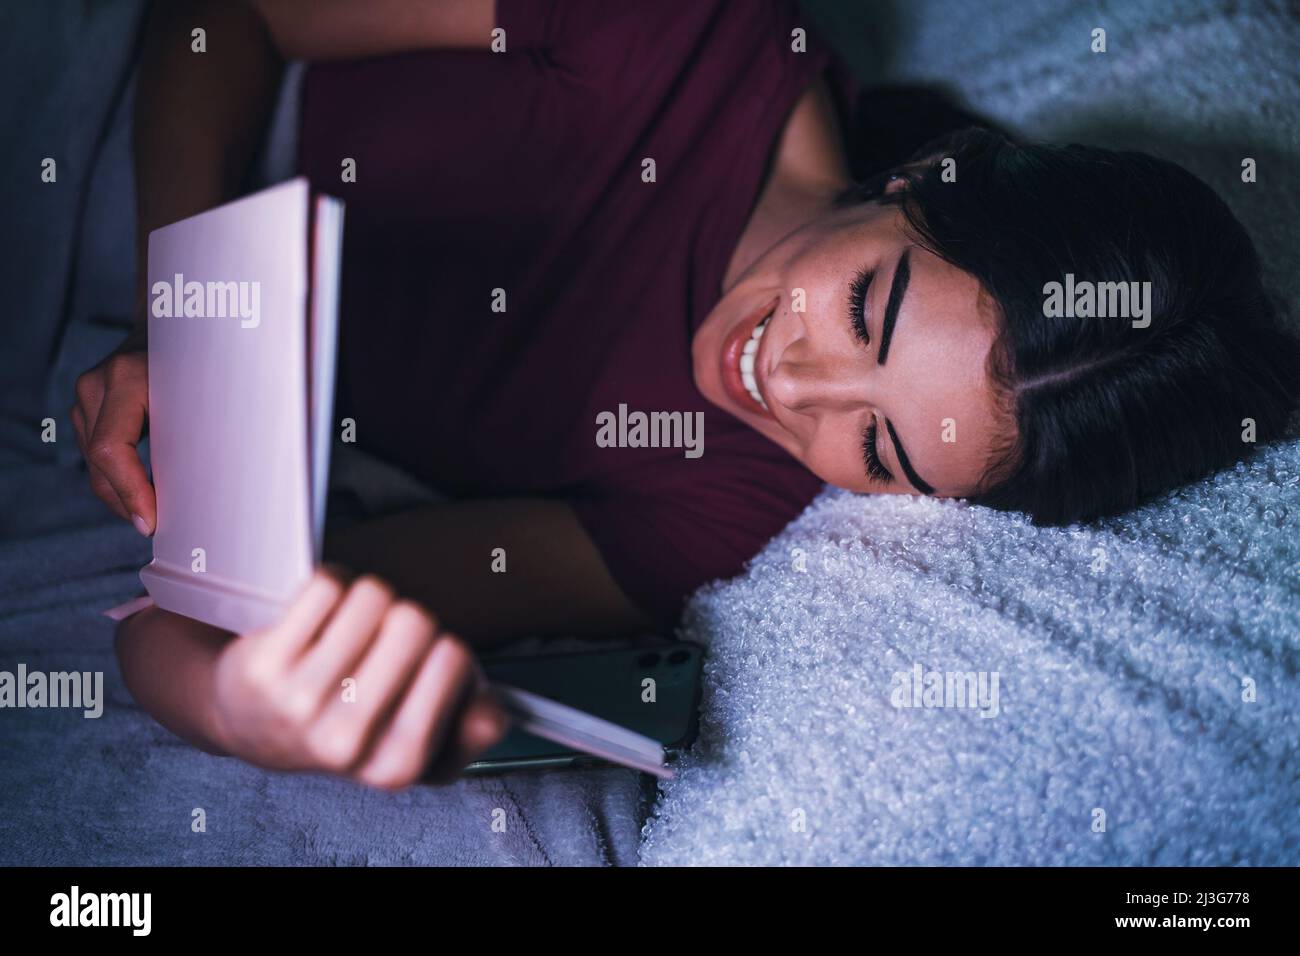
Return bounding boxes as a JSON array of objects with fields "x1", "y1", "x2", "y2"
[{"x1": 0, "y1": 0, "x2": 1300, "y2": 865}]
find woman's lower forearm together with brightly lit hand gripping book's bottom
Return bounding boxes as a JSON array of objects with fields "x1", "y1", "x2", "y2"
[{"x1": 117, "y1": 571, "x2": 507, "y2": 788}]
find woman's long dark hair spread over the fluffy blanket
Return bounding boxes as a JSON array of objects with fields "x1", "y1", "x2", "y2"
[{"x1": 841, "y1": 127, "x2": 1300, "y2": 524}]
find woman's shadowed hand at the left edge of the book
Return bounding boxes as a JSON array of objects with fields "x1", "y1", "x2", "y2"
[{"x1": 72, "y1": 333, "x2": 157, "y2": 536}]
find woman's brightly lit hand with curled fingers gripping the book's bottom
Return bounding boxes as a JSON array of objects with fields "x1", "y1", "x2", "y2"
[{"x1": 212, "y1": 571, "x2": 507, "y2": 790}]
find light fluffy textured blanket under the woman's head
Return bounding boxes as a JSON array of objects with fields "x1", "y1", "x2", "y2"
[{"x1": 642, "y1": 444, "x2": 1300, "y2": 865}]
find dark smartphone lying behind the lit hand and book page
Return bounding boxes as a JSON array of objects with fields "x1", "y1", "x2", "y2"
[{"x1": 464, "y1": 641, "x2": 703, "y2": 774}]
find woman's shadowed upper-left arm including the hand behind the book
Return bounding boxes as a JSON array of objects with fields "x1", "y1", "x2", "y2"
[{"x1": 72, "y1": 0, "x2": 281, "y2": 535}]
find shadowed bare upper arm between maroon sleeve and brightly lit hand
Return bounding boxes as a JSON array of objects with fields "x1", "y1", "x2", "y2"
[{"x1": 325, "y1": 498, "x2": 654, "y2": 646}]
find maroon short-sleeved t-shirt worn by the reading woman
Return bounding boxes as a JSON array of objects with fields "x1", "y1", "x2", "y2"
[{"x1": 300, "y1": 0, "x2": 853, "y2": 620}]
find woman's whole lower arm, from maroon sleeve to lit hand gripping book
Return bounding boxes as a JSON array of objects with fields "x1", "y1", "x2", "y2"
[{"x1": 116, "y1": 499, "x2": 651, "y2": 787}]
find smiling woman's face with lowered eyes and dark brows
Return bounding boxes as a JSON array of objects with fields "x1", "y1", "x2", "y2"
[{"x1": 692, "y1": 193, "x2": 1015, "y2": 497}]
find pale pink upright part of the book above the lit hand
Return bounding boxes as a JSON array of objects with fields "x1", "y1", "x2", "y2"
[{"x1": 140, "y1": 178, "x2": 343, "y2": 632}]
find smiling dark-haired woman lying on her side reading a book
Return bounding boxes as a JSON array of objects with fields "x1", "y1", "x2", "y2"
[{"x1": 74, "y1": 0, "x2": 1297, "y2": 787}]
